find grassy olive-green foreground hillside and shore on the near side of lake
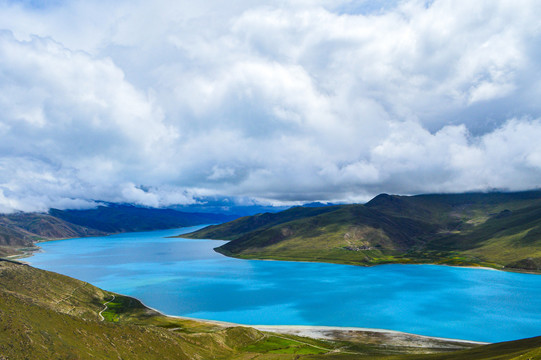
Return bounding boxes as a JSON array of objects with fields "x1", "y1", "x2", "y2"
[{"x1": 0, "y1": 260, "x2": 541, "y2": 360}]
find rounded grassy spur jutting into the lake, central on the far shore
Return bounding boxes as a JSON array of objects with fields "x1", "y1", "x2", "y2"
[{"x1": 213, "y1": 205, "x2": 434, "y2": 263}]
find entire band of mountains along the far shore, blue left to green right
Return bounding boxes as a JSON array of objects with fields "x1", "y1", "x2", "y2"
[{"x1": 6, "y1": 191, "x2": 541, "y2": 272}]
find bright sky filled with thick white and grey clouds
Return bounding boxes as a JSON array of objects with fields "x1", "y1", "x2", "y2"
[{"x1": 0, "y1": 0, "x2": 541, "y2": 212}]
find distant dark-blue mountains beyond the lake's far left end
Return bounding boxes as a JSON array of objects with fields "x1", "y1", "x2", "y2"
[{"x1": 0, "y1": 204, "x2": 236, "y2": 256}]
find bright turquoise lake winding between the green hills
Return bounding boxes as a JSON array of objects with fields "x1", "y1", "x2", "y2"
[{"x1": 25, "y1": 227, "x2": 541, "y2": 342}]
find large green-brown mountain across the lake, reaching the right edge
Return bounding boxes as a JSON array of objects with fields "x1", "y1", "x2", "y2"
[{"x1": 182, "y1": 191, "x2": 541, "y2": 272}]
